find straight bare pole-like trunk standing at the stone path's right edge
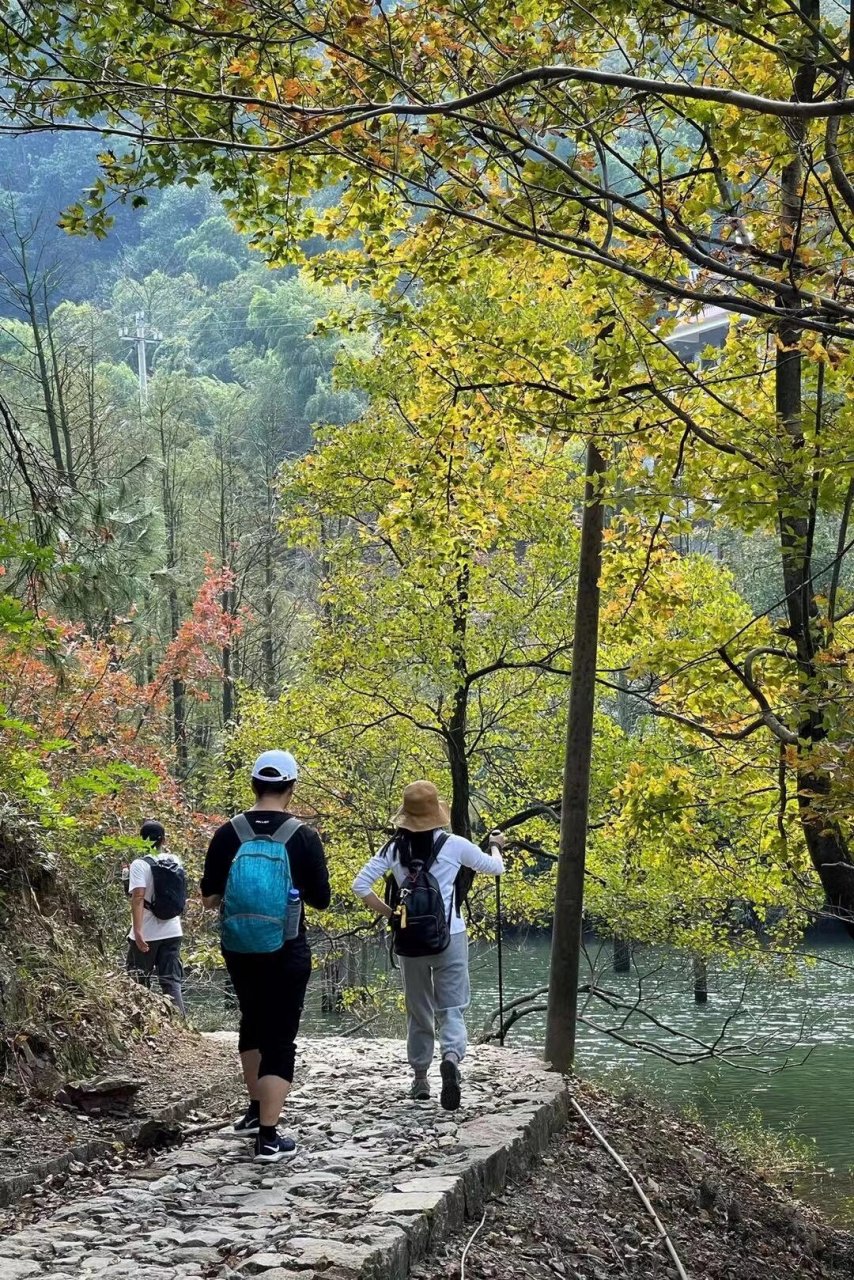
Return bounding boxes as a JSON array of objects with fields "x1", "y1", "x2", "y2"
[{"x1": 545, "y1": 442, "x2": 606, "y2": 1071}]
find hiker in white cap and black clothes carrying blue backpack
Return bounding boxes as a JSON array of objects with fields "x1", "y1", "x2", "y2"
[{"x1": 201, "y1": 751, "x2": 330, "y2": 1164}]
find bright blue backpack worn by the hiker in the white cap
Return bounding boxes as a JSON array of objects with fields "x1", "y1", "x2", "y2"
[{"x1": 220, "y1": 813, "x2": 302, "y2": 955}]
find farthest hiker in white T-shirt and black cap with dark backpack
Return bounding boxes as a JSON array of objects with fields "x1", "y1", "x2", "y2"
[{"x1": 127, "y1": 819, "x2": 187, "y2": 1014}]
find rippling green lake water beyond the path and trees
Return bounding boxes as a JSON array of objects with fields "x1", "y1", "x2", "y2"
[{"x1": 188, "y1": 934, "x2": 854, "y2": 1224}]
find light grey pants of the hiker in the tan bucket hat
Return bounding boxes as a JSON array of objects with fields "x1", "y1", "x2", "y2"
[{"x1": 399, "y1": 931, "x2": 471, "y2": 1075}]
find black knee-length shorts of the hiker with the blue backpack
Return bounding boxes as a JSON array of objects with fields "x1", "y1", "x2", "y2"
[{"x1": 223, "y1": 934, "x2": 311, "y2": 1082}]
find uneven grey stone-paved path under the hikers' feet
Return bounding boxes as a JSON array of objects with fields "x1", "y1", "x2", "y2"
[{"x1": 0, "y1": 1038, "x2": 566, "y2": 1280}]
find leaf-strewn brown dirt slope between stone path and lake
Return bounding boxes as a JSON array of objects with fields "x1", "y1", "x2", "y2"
[{"x1": 412, "y1": 1082, "x2": 854, "y2": 1280}]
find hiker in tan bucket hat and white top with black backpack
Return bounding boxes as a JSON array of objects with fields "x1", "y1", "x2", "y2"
[{"x1": 353, "y1": 782, "x2": 504, "y2": 1111}]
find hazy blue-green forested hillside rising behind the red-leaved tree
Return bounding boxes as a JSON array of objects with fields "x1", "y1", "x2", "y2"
[{"x1": 0, "y1": 137, "x2": 360, "y2": 701}]
